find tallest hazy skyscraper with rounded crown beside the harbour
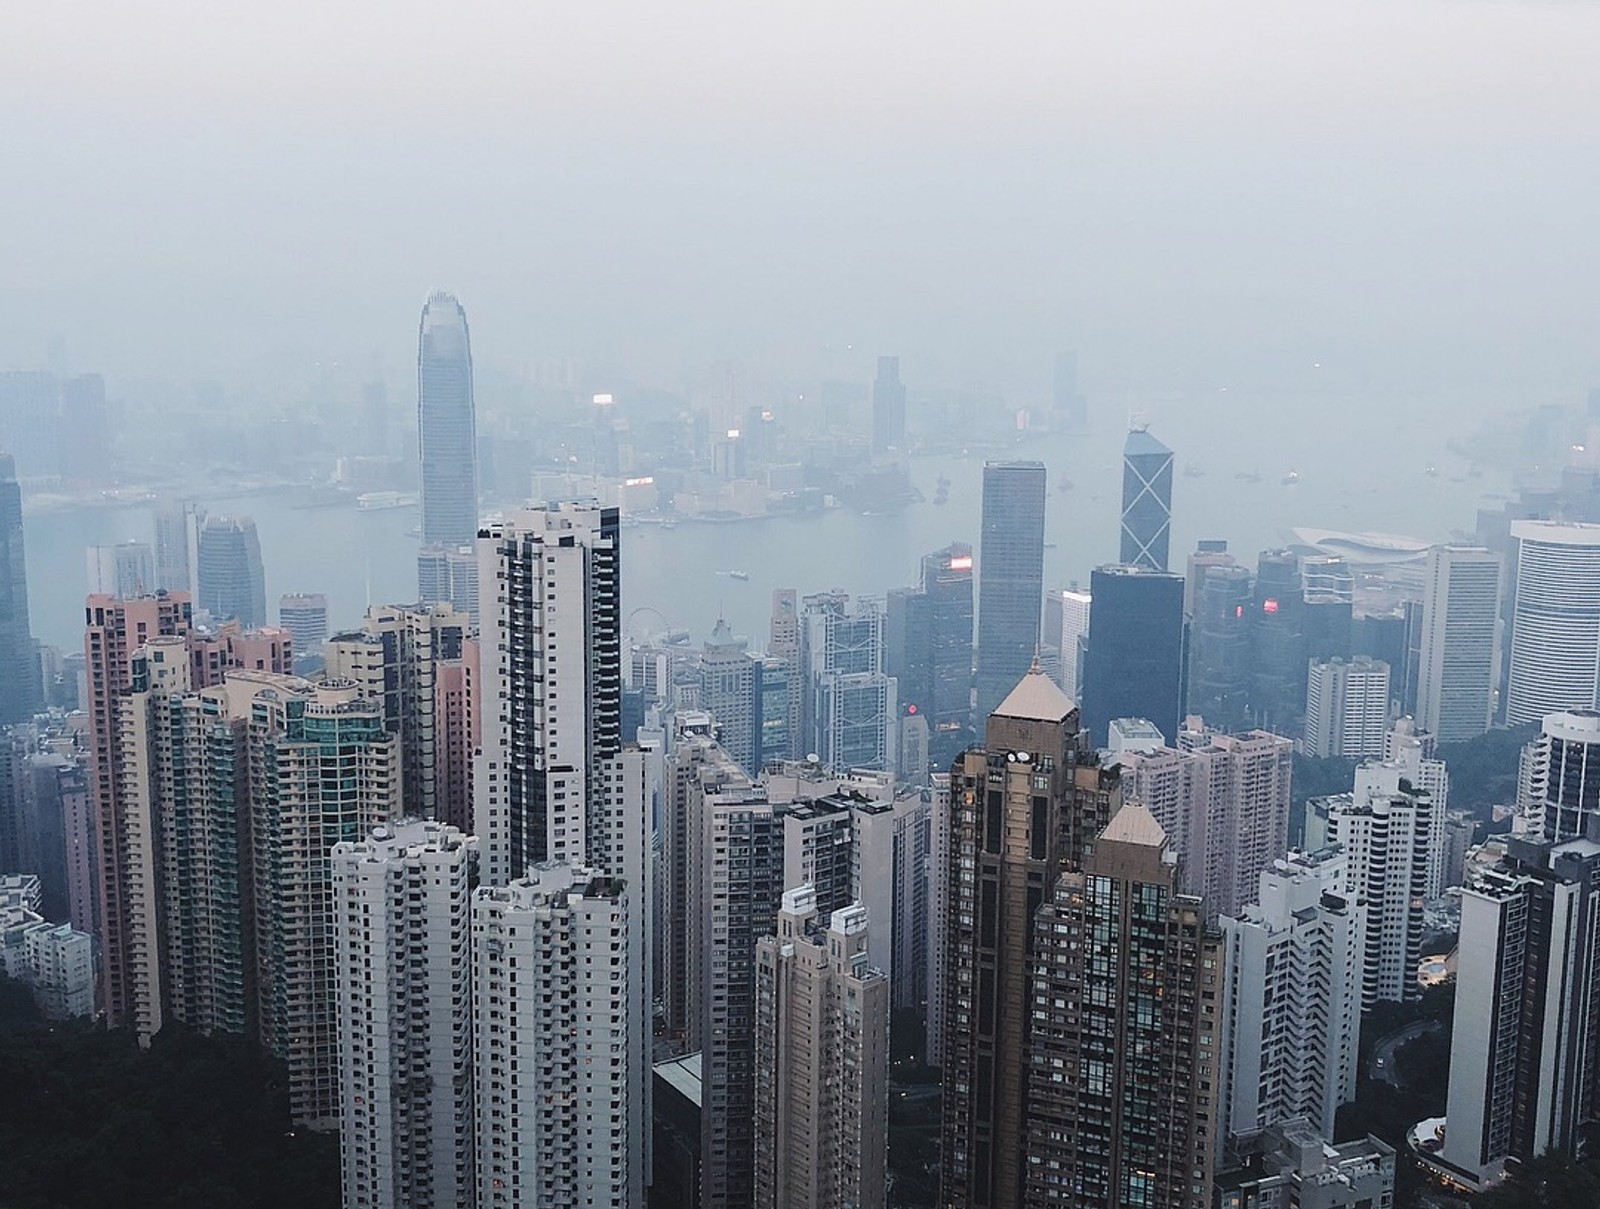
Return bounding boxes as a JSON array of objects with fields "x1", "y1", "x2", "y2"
[{"x1": 416, "y1": 291, "x2": 478, "y2": 545}]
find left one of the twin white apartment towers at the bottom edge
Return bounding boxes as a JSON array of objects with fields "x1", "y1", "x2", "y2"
[{"x1": 331, "y1": 820, "x2": 476, "y2": 1209}]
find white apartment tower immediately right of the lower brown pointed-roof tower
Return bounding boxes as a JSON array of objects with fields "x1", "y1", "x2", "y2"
[{"x1": 1219, "y1": 849, "x2": 1366, "y2": 1137}]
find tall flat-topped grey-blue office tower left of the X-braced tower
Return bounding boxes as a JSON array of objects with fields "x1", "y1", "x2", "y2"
[{"x1": 978, "y1": 462, "x2": 1045, "y2": 718}]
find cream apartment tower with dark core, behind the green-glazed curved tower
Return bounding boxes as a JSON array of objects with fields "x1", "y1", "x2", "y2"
[{"x1": 325, "y1": 605, "x2": 470, "y2": 819}]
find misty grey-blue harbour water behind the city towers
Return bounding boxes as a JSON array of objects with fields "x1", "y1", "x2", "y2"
[{"x1": 26, "y1": 387, "x2": 1509, "y2": 649}]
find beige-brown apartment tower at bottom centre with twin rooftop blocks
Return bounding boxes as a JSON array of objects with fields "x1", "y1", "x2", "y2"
[{"x1": 754, "y1": 886, "x2": 890, "y2": 1209}]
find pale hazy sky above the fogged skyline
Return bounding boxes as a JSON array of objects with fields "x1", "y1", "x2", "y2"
[{"x1": 0, "y1": 0, "x2": 1600, "y2": 401}]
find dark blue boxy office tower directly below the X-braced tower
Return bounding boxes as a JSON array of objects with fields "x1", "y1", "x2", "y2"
[{"x1": 1083, "y1": 566, "x2": 1186, "y2": 744}]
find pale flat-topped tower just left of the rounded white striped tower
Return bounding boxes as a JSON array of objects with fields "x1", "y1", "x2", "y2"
[{"x1": 1416, "y1": 545, "x2": 1501, "y2": 744}]
